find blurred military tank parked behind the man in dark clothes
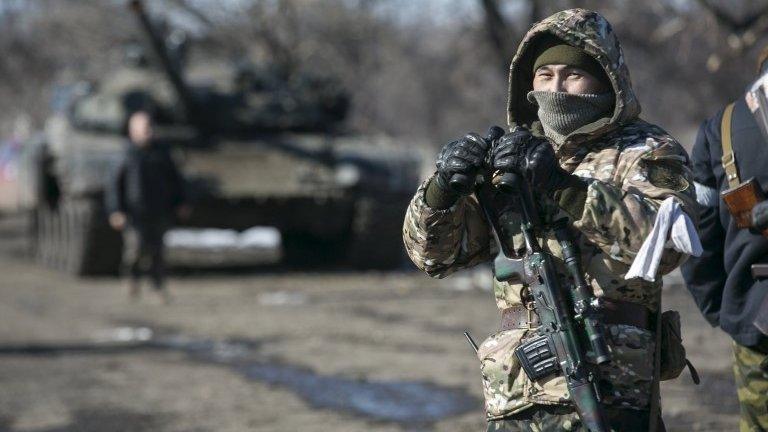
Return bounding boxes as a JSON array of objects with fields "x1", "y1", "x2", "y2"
[{"x1": 6, "y1": 0, "x2": 421, "y2": 275}]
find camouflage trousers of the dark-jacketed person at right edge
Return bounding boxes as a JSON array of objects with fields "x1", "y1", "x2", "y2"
[{"x1": 733, "y1": 342, "x2": 768, "y2": 432}]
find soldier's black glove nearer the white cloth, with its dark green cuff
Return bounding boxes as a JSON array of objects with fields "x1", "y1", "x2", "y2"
[{"x1": 491, "y1": 129, "x2": 587, "y2": 218}]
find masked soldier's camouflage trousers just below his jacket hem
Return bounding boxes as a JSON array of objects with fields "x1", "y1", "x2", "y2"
[{"x1": 487, "y1": 405, "x2": 665, "y2": 432}]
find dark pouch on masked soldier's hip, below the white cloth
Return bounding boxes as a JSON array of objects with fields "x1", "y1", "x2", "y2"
[{"x1": 659, "y1": 310, "x2": 699, "y2": 384}]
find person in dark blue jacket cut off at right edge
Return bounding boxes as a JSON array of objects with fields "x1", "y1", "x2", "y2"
[{"x1": 682, "y1": 52, "x2": 768, "y2": 431}]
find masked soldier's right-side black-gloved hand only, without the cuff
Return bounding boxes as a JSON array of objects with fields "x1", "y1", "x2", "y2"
[{"x1": 491, "y1": 129, "x2": 570, "y2": 194}]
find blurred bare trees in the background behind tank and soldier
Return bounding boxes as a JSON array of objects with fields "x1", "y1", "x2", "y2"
[{"x1": 0, "y1": 0, "x2": 768, "y2": 145}]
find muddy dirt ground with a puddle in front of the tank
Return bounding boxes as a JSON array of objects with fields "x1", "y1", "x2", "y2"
[{"x1": 0, "y1": 238, "x2": 737, "y2": 432}]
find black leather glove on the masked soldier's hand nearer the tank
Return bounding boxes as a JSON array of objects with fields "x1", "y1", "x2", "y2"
[{"x1": 425, "y1": 133, "x2": 489, "y2": 209}]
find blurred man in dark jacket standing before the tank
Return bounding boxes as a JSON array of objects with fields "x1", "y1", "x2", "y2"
[{"x1": 106, "y1": 111, "x2": 189, "y2": 303}]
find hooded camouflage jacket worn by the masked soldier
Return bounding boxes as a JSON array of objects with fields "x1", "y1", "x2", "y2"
[{"x1": 403, "y1": 9, "x2": 696, "y2": 419}]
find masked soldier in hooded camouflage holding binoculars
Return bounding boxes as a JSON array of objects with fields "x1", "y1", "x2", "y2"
[{"x1": 403, "y1": 9, "x2": 695, "y2": 432}]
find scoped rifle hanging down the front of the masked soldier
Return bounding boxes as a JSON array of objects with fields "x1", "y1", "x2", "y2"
[{"x1": 462, "y1": 127, "x2": 611, "y2": 432}]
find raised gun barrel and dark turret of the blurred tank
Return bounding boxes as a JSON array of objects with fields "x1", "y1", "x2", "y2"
[{"x1": 130, "y1": 0, "x2": 349, "y2": 134}]
